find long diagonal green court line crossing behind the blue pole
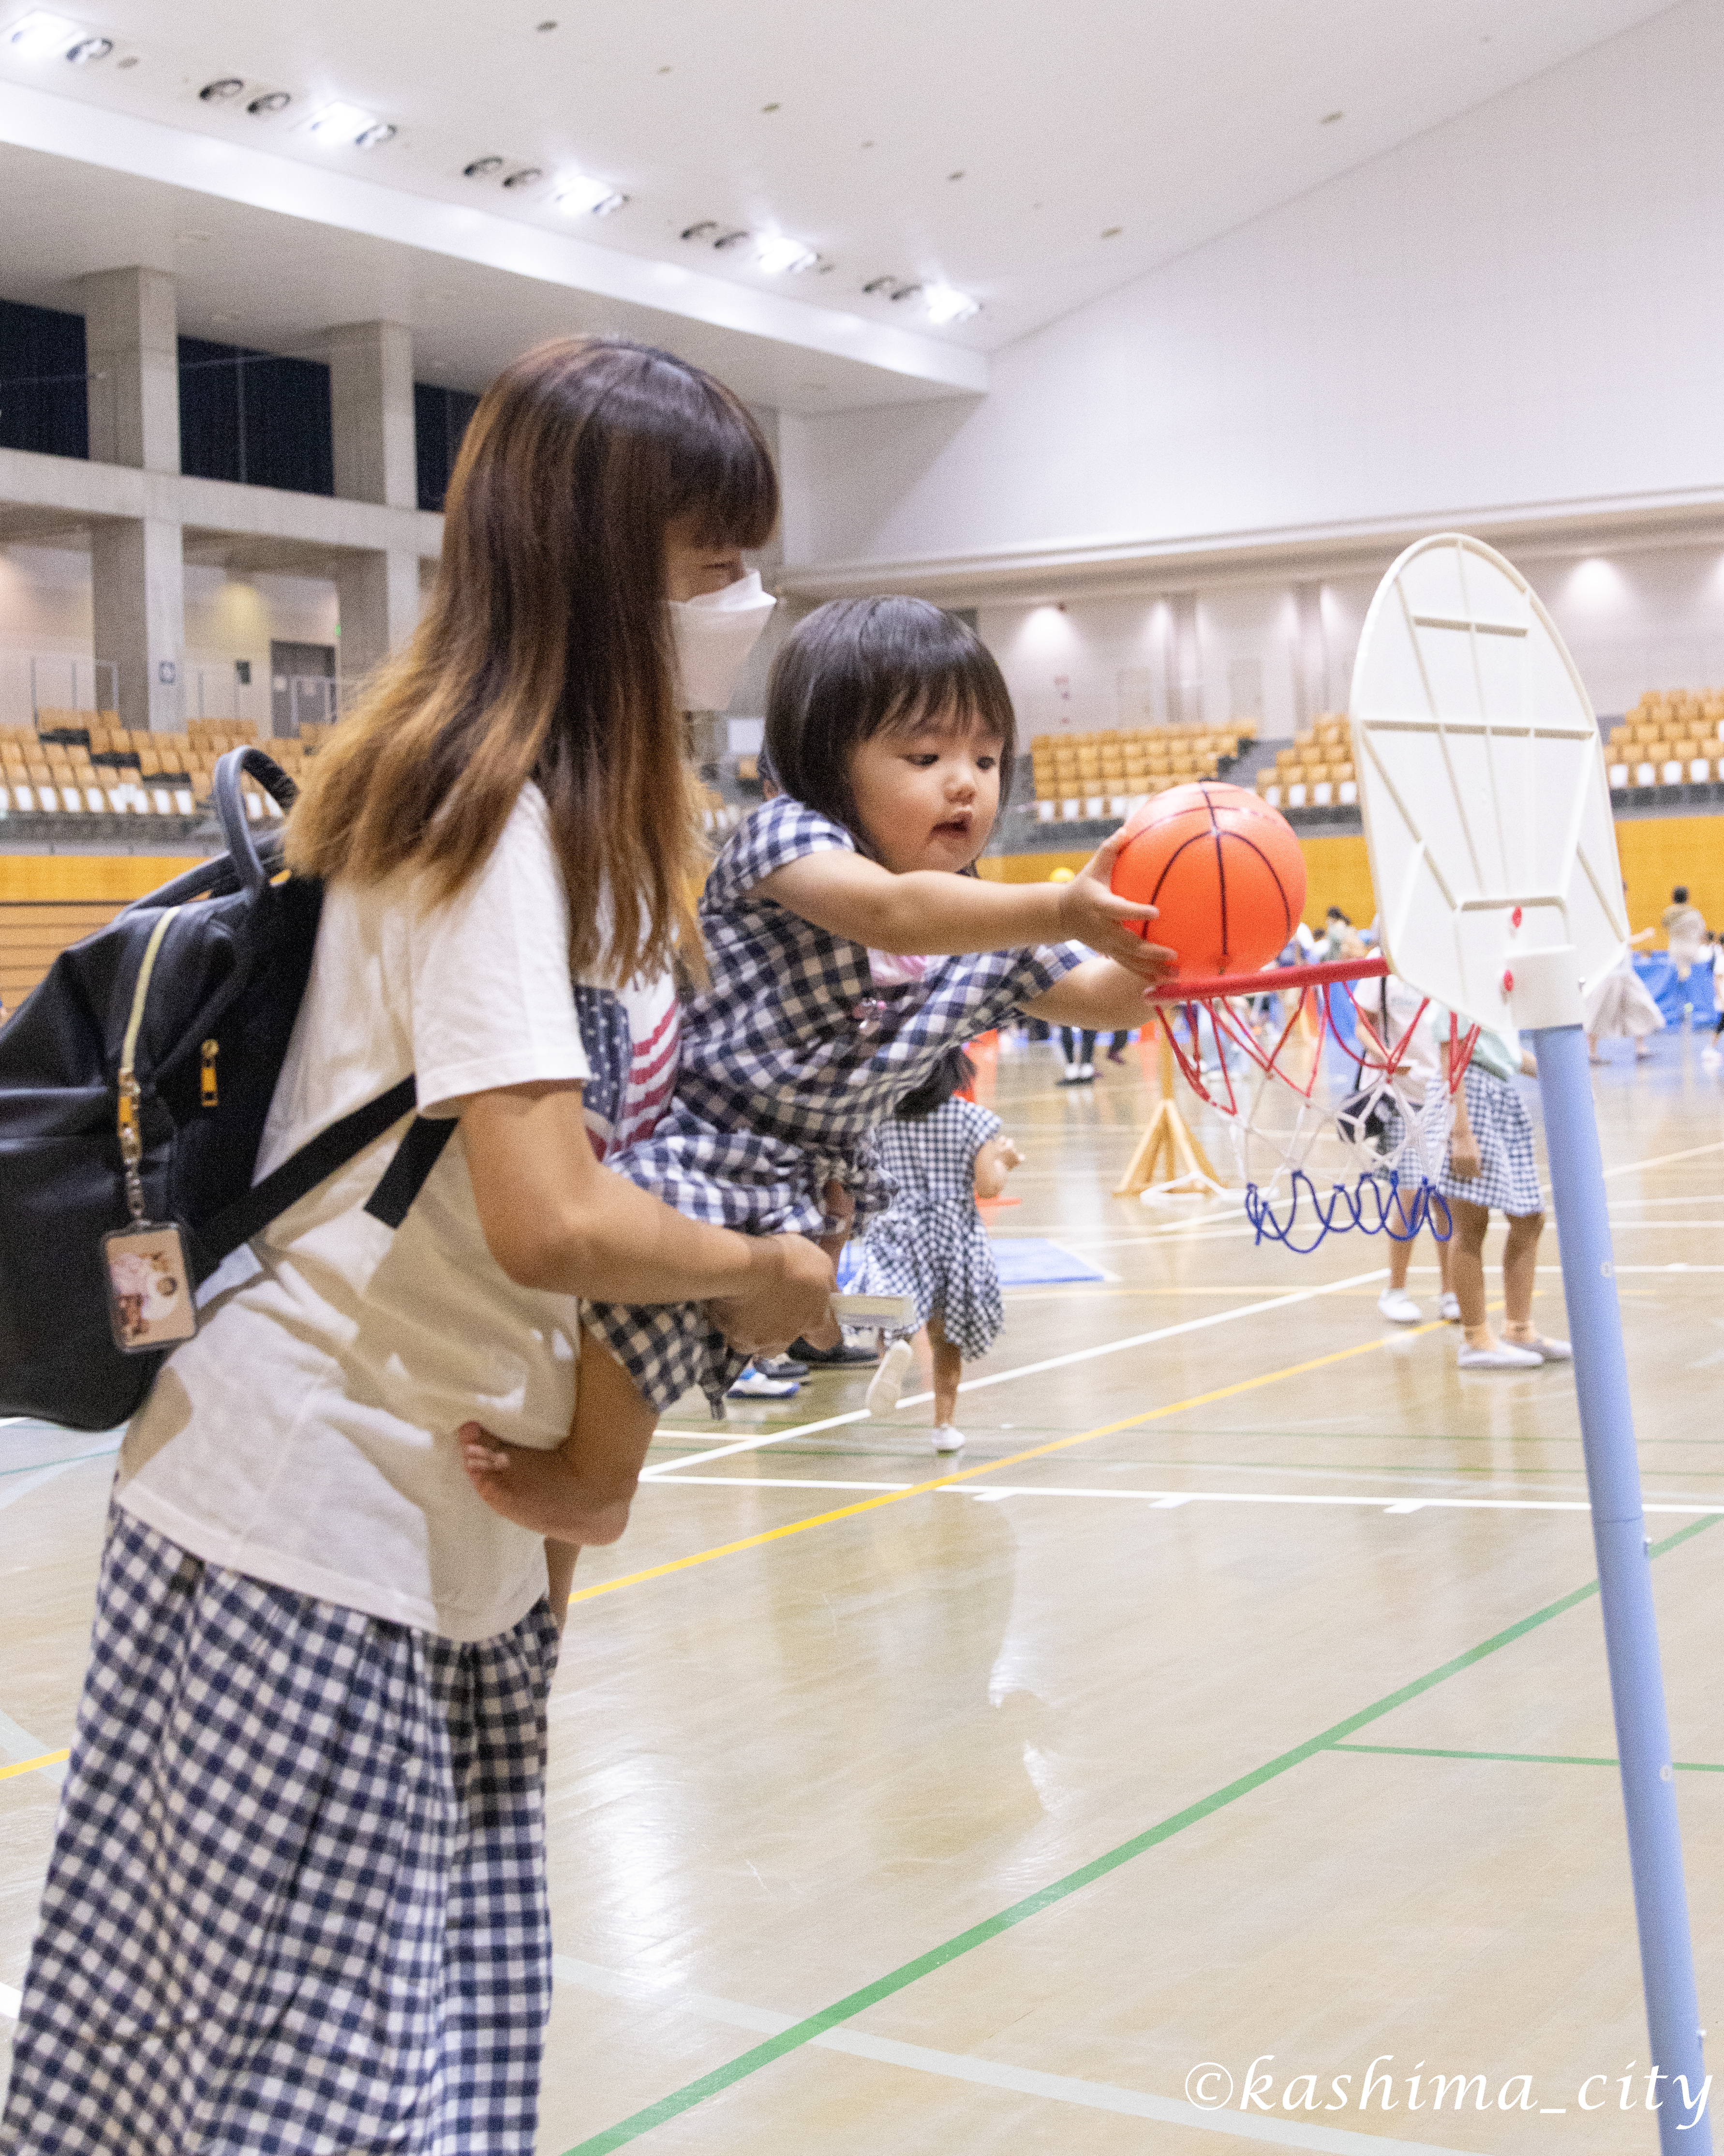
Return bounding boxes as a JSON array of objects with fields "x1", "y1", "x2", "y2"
[{"x1": 565, "y1": 1516, "x2": 1720, "y2": 2156}]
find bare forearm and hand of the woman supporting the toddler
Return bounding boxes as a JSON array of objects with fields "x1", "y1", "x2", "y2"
[{"x1": 461, "y1": 1084, "x2": 834, "y2": 1349}]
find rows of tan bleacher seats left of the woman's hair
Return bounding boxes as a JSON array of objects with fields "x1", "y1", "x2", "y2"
[{"x1": 0, "y1": 709, "x2": 332, "y2": 822}]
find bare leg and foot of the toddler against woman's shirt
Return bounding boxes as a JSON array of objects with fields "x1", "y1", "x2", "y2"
[{"x1": 461, "y1": 1333, "x2": 657, "y2": 1552}]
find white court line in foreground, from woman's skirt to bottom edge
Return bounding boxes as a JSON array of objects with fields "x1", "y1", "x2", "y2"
[{"x1": 551, "y1": 1953, "x2": 1457, "y2": 2156}]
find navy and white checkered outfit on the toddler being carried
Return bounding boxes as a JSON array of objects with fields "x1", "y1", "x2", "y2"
[{"x1": 584, "y1": 794, "x2": 1084, "y2": 1408}]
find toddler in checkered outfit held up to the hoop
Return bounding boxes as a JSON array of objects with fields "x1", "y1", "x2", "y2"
[{"x1": 468, "y1": 599, "x2": 1173, "y2": 1535}]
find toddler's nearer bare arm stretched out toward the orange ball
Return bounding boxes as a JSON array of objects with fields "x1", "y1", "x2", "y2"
[{"x1": 757, "y1": 832, "x2": 1173, "y2": 981}]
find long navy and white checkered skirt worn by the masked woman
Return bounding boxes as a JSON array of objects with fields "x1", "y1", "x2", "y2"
[{"x1": 0, "y1": 1509, "x2": 556, "y2": 2156}]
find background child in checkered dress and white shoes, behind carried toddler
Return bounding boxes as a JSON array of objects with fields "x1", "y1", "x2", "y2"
[{"x1": 853, "y1": 1048, "x2": 1022, "y2": 1453}]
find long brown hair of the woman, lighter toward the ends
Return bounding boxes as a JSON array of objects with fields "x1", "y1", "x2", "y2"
[{"x1": 287, "y1": 336, "x2": 778, "y2": 981}]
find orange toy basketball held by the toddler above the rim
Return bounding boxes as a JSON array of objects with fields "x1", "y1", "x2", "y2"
[{"x1": 1114, "y1": 779, "x2": 1306, "y2": 981}]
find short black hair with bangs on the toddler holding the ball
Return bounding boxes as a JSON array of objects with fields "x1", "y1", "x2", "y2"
[{"x1": 765, "y1": 599, "x2": 1017, "y2": 852}]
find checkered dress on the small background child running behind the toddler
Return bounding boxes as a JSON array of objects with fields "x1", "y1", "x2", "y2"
[{"x1": 856, "y1": 1100, "x2": 1006, "y2": 1362}]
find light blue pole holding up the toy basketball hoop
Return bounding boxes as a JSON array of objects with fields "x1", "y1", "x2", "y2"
[{"x1": 1532, "y1": 1024, "x2": 1711, "y2": 2156}]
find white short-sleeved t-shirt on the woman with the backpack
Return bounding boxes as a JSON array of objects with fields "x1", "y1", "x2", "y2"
[{"x1": 117, "y1": 787, "x2": 655, "y2": 1641}]
